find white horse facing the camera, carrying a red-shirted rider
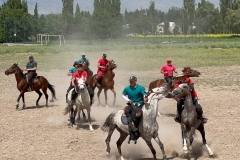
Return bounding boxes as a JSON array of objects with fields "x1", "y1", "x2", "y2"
[{"x1": 64, "y1": 77, "x2": 94, "y2": 131}]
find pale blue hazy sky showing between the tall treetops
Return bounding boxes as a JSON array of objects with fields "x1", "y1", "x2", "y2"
[{"x1": 0, "y1": 0, "x2": 219, "y2": 14}]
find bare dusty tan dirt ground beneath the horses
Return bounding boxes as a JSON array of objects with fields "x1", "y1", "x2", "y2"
[{"x1": 0, "y1": 54, "x2": 240, "y2": 160}]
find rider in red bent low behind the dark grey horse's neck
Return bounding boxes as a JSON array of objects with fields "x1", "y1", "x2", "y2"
[{"x1": 174, "y1": 73, "x2": 207, "y2": 123}]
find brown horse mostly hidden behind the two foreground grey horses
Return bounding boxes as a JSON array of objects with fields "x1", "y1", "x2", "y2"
[{"x1": 148, "y1": 66, "x2": 201, "y2": 92}]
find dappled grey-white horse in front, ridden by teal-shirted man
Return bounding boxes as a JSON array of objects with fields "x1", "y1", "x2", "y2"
[{"x1": 102, "y1": 87, "x2": 167, "y2": 160}]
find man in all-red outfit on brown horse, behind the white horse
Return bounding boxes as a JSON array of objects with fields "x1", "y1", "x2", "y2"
[{"x1": 97, "y1": 54, "x2": 115, "y2": 84}]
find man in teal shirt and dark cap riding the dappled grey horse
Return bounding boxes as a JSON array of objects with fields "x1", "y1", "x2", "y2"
[{"x1": 122, "y1": 76, "x2": 148, "y2": 143}]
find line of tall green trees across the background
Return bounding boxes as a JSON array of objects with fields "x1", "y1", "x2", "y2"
[{"x1": 0, "y1": 0, "x2": 240, "y2": 42}]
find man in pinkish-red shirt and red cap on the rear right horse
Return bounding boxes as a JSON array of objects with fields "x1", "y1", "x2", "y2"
[{"x1": 161, "y1": 58, "x2": 177, "y2": 90}]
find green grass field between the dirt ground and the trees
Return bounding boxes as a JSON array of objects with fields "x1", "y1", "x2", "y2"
[{"x1": 0, "y1": 42, "x2": 240, "y2": 90}]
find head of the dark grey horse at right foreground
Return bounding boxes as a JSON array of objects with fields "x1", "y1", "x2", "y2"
[{"x1": 172, "y1": 83, "x2": 191, "y2": 99}]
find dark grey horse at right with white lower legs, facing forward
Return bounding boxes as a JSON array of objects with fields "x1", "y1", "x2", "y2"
[{"x1": 172, "y1": 83, "x2": 213, "y2": 156}]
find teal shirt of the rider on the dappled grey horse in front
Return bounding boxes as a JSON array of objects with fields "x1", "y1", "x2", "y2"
[{"x1": 122, "y1": 84, "x2": 146, "y2": 104}]
